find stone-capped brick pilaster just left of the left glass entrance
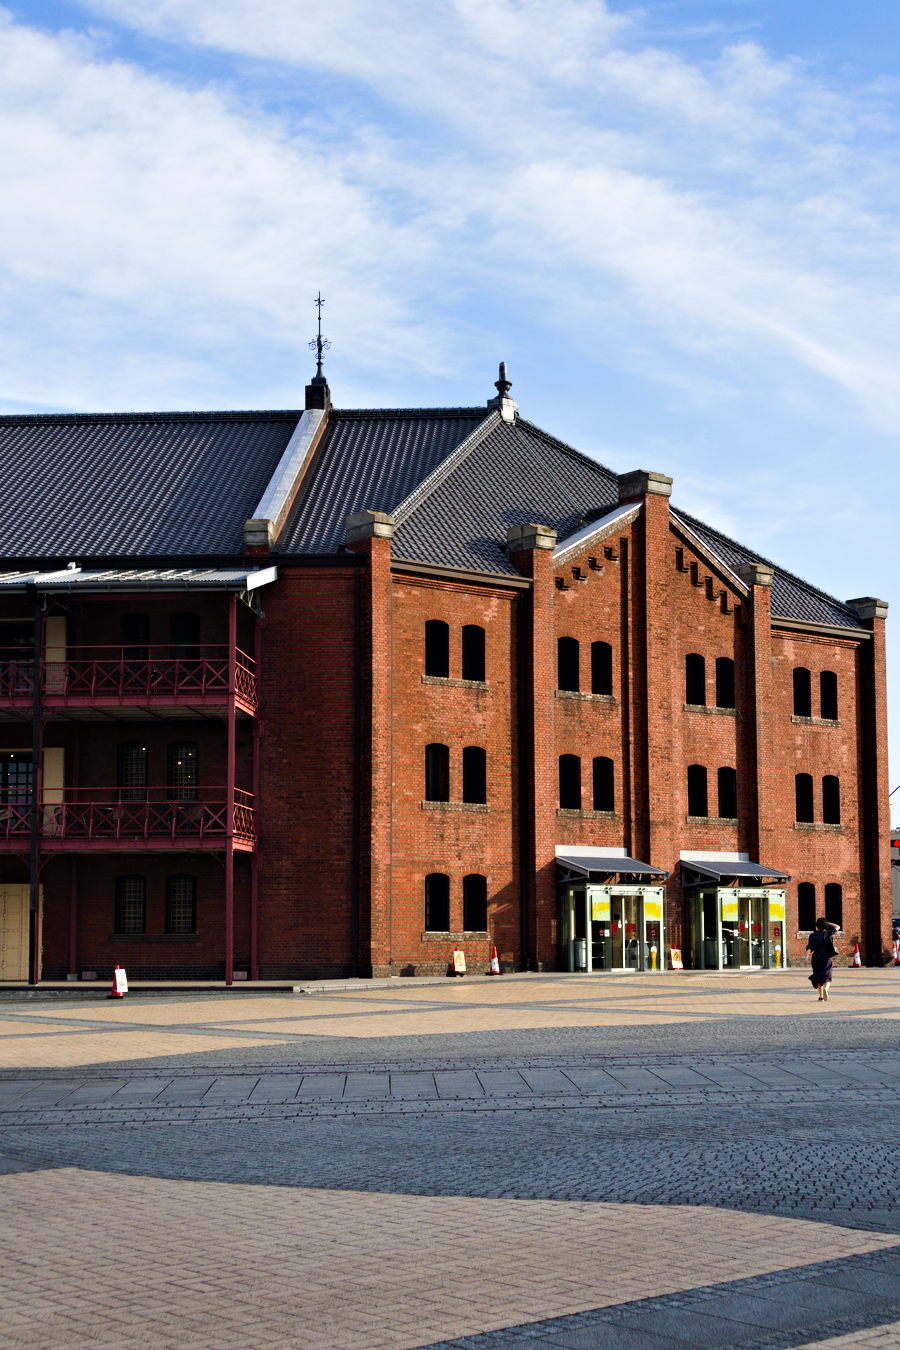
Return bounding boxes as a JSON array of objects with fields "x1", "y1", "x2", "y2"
[{"x1": 506, "y1": 525, "x2": 559, "y2": 971}]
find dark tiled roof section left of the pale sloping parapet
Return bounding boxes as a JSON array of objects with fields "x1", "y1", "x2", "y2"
[{"x1": 0, "y1": 412, "x2": 300, "y2": 559}]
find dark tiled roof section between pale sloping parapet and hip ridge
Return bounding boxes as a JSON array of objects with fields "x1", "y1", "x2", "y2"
[{"x1": 278, "y1": 408, "x2": 487, "y2": 554}]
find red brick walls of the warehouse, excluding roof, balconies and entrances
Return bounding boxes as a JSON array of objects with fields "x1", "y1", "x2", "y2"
[{"x1": 0, "y1": 413, "x2": 891, "y2": 979}]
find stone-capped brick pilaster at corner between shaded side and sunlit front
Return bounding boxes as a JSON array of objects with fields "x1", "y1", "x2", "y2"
[{"x1": 347, "y1": 510, "x2": 394, "y2": 975}]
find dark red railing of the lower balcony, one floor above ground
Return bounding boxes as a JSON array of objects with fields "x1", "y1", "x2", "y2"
[{"x1": 0, "y1": 787, "x2": 256, "y2": 848}]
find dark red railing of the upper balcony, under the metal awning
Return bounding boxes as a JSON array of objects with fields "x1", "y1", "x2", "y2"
[{"x1": 0, "y1": 645, "x2": 258, "y2": 709}]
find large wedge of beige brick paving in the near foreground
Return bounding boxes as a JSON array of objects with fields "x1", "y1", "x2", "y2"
[{"x1": 0, "y1": 1169, "x2": 897, "y2": 1350}]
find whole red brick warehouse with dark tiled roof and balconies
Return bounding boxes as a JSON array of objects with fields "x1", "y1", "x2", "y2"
[{"x1": 0, "y1": 356, "x2": 891, "y2": 981}]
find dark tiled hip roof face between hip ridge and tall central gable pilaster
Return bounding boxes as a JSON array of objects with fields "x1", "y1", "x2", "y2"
[{"x1": 394, "y1": 419, "x2": 618, "y2": 574}]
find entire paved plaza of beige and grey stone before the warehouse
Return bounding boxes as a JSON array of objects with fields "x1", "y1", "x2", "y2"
[{"x1": 0, "y1": 969, "x2": 900, "y2": 1350}]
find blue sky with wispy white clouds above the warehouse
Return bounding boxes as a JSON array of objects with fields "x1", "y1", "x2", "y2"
[{"x1": 0, "y1": 0, "x2": 900, "y2": 818}]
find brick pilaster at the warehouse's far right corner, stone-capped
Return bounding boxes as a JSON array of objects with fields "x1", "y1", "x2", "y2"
[{"x1": 847, "y1": 597, "x2": 892, "y2": 965}]
